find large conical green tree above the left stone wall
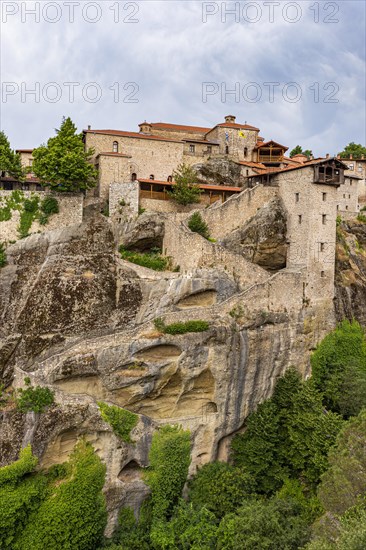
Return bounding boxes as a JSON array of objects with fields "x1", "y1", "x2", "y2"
[{"x1": 32, "y1": 118, "x2": 97, "y2": 191}]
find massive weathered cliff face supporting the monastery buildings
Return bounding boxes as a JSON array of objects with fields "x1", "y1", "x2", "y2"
[{"x1": 0, "y1": 203, "x2": 334, "y2": 534}]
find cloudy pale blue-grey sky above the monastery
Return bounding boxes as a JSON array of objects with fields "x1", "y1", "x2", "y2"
[{"x1": 0, "y1": 0, "x2": 366, "y2": 155}]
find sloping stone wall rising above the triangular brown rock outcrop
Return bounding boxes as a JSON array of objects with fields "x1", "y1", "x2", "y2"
[{"x1": 203, "y1": 185, "x2": 278, "y2": 239}]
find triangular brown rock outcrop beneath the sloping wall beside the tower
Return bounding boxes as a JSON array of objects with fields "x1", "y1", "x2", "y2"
[{"x1": 221, "y1": 197, "x2": 287, "y2": 271}]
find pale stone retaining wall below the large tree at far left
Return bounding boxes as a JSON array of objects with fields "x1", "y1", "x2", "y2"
[{"x1": 0, "y1": 191, "x2": 84, "y2": 242}]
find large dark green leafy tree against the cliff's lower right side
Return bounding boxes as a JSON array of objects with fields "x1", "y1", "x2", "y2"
[{"x1": 232, "y1": 369, "x2": 343, "y2": 494}]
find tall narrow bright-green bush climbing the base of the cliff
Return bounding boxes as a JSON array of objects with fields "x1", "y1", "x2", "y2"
[{"x1": 145, "y1": 425, "x2": 191, "y2": 524}]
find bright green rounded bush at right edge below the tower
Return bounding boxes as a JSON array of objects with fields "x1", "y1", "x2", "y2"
[{"x1": 311, "y1": 321, "x2": 366, "y2": 417}]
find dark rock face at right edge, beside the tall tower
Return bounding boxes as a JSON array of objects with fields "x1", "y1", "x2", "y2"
[{"x1": 335, "y1": 220, "x2": 366, "y2": 326}]
